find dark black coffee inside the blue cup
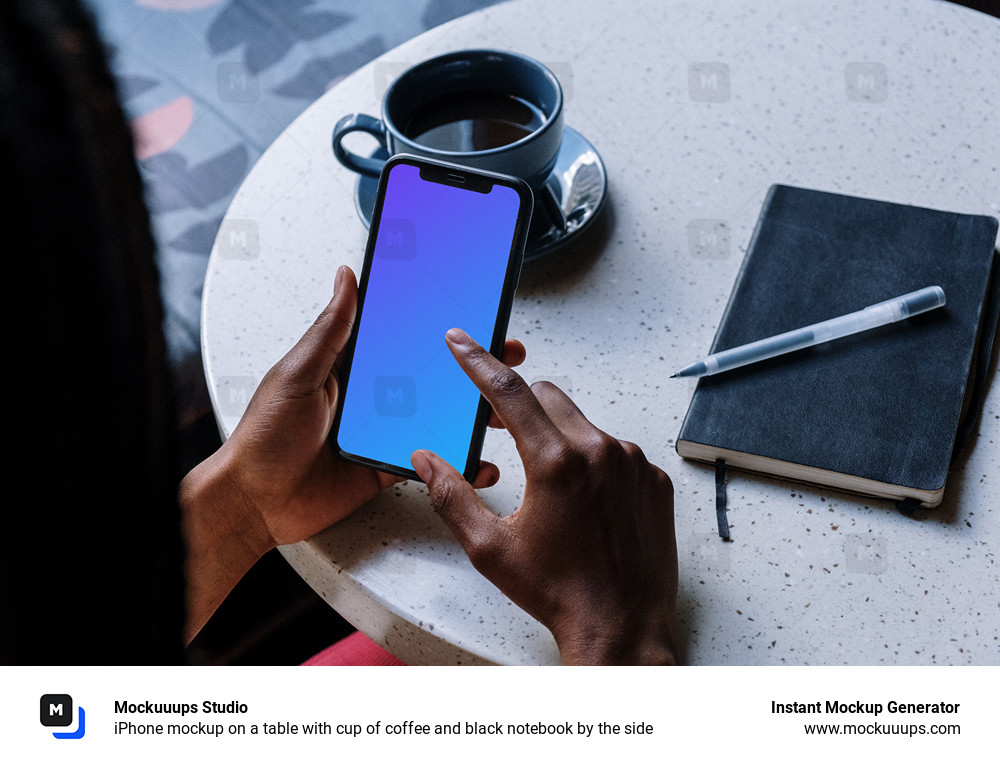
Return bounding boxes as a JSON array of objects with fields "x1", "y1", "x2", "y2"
[{"x1": 403, "y1": 90, "x2": 545, "y2": 152}]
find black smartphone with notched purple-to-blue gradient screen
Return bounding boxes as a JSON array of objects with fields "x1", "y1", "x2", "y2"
[{"x1": 331, "y1": 155, "x2": 532, "y2": 481}]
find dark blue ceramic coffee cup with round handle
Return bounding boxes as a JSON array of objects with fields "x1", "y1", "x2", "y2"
[{"x1": 333, "y1": 50, "x2": 563, "y2": 189}]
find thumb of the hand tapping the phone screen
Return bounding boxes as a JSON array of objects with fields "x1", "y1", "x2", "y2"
[{"x1": 410, "y1": 450, "x2": 506, "y2": 568}]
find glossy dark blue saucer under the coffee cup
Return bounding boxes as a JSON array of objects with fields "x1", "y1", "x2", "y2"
[{"x1": 354, "y1": 127, "x2": 608, "y2": 262}]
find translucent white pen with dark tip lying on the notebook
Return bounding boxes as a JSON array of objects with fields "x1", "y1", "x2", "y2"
[{"x1": 670, "y1": 285, "x2": 944, "y2": 378}]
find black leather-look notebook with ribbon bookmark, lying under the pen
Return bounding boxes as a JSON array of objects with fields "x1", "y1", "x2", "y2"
[{"x1": 677, "y1": 186, "x2": 1000, "y2": 506}]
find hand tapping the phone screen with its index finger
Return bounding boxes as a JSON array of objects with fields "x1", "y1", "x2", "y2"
[{"x1": 411, "y1": 330, "x2": 677, "y2": 664}]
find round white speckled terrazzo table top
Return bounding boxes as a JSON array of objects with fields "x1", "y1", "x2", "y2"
[{"x1": 202, "y1": 0, "x2": 1000, "y2": 665}]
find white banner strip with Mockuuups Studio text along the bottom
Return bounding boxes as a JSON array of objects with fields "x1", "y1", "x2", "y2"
[{"x1": 0, "y1": 667, "x2": 1000, "y2": 766}]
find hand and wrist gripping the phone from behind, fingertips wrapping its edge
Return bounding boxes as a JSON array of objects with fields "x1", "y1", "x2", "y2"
[{"x1": 181, "y1": 266, "x2": 525, "y2": 635}]
